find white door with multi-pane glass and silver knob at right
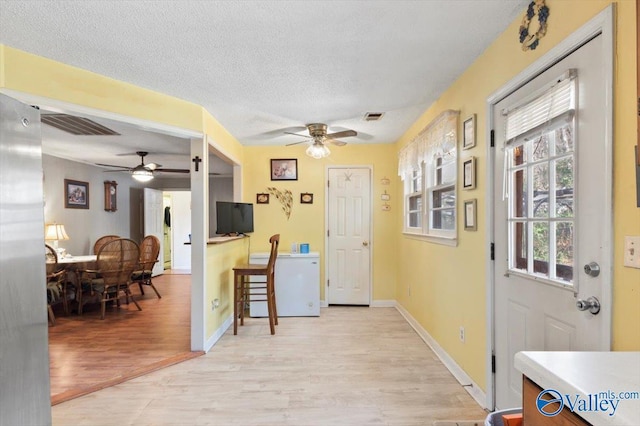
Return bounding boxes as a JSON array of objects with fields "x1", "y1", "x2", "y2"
[{"x1": 493, "y1": 36, "x2": 612, "y2": 409}]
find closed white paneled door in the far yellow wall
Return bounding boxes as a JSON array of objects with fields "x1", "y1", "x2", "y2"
[{"x1": 328, "y1": 168, "x2": 371, "y2": 305}]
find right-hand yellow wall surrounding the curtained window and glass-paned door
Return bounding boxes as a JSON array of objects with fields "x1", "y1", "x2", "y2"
[{"x1": 396, "y1": 0, "x2": 640, "y2": 388}]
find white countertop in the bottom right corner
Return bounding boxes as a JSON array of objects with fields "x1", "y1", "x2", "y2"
[{"x1": 515, "y1": 351, "x2": 640, "y2": 426}]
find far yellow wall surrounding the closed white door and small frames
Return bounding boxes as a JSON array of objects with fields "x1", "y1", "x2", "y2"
[{"x1": 243, "y1": 144, "x2": 401, "y2": 300}]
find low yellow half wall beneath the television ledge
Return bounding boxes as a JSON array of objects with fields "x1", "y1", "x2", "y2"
[{"x1": 204, "y1": 238, "x2": 249, "y2": 336}]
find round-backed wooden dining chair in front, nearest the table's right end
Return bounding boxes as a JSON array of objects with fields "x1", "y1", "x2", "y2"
[{"x1": 82, "y1": 238, "x2": 142, "y2": 319}]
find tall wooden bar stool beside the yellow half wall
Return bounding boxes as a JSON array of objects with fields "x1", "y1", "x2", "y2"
[{"x1": 233, "y1": 234, "x2": 280, "y2": 334}]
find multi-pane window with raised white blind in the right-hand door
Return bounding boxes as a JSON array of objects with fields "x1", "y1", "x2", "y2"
[{"x1": 503, "y1": 70, "x2": 577, "y2": 286}]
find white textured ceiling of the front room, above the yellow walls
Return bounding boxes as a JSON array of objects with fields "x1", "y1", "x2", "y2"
[{"x1": 0, "y1": 0, "x2": 528, "y2": 166}]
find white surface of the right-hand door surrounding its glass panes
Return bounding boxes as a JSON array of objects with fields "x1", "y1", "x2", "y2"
[{"x1": 492, "y1": 36, "x2": 612, "y2": 409}]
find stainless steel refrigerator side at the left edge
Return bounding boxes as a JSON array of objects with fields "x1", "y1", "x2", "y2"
[{"x1": 0, "y1": 94, "x2": 51, "y2": 426}]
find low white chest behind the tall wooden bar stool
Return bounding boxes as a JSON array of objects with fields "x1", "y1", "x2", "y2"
[{"x1": 249, "y1": 252, "x2": 320, "y2": 317}]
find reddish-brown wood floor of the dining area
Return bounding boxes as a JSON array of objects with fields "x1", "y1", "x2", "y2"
[{"x1": 49, "y1": 274, "x2": 201, "y2": 405}]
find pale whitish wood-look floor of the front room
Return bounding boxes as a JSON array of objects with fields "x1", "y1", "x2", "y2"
[{"x1": 52, "y1": 307, "x2": 486, "y2": 426}]
